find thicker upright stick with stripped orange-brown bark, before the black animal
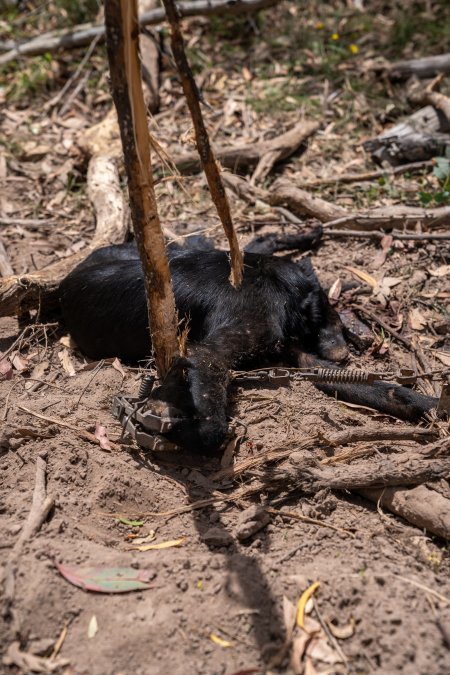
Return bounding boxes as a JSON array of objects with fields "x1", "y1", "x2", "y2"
[{"x1": 105, "y1": 0, "x2": 179, "y2": 377}]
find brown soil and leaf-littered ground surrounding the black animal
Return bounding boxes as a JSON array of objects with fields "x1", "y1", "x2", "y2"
[{"x1": 0, "y1": 2, "x2": 450, "y2": 675}]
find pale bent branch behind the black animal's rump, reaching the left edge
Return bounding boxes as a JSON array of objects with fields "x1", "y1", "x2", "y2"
[{"x1": 0, "y1": 157, "x2": 128, "y2": 316}]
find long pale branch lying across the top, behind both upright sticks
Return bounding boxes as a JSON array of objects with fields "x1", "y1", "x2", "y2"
[{"x1": 0, "y1": 0, "x2": 277, "y2": 65}]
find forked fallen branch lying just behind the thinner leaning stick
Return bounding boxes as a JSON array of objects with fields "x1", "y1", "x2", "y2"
[{"x1": 175, "y1": 121, "x2": 320, "y2": 176}]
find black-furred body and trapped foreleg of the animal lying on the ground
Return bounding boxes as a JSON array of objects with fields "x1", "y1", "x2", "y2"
[{"x1": 60, "y1": 239, "x2": 434, "y2": 452}]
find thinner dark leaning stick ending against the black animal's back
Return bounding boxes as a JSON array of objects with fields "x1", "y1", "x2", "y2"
[{"x1": 163, "y1": 0, "x2": 244, "y2": 287}]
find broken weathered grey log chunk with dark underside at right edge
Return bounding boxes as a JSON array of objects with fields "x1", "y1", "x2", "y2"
[{"x1": 363, "y1": 105, "x2": 450, "y2": 166}]
